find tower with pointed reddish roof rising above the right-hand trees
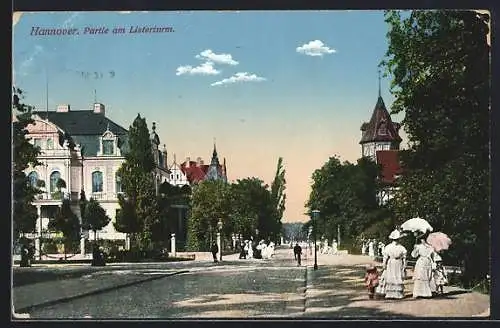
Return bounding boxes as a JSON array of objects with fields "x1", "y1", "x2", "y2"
[{"x1": 359, "y1": 89, "x2": 402, "y2": 204}]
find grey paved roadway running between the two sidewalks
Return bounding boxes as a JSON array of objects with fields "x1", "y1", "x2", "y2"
[{"x1": 22, "y1": 250, "x2": 306, "y2": 319}]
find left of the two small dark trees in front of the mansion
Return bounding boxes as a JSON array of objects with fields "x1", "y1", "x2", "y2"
[{"x1": 48, "y1": 199, "x2": 80, "y2": 254}]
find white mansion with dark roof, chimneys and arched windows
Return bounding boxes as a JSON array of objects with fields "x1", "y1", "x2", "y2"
[{"x1": 26, "y1": 103, "x2": 168, "y2": 255}]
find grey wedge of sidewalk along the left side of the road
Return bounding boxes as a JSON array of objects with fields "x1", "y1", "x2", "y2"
[{"x1": 12, "y1": 270, "x2": 188, "y2": 313}]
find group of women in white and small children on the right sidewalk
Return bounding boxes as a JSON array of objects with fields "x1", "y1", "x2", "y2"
[{"x1": 365, "y1": 230, "x2": 448, "y2": 299}]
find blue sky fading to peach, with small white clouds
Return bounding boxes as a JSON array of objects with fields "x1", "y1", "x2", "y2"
[{"x1": 12, "y1": 10, "x2": 405, "y2": 222}]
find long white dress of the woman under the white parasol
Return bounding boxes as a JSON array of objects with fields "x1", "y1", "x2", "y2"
[{"x1": 411, "y1": 243, "x2": 434, "y2": 297}]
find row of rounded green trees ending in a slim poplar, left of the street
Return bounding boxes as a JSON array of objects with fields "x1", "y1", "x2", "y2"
[{"x1": 188, "y1": 157, "x2": 286, "y2": 250}]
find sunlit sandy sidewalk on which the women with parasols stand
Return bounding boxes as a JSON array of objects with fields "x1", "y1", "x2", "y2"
[{"x1": 304, "y1": 254, "x2": 490, "y2": 319}]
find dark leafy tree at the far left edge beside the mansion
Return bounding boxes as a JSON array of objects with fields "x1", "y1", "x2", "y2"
[{"x1": 12, "y1": 88, "x2": 41, "y2": 238}]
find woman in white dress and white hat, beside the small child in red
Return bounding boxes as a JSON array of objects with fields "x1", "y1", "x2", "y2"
[{"x1": 382, "y1": 230, "x2": 407, "y2": 299}]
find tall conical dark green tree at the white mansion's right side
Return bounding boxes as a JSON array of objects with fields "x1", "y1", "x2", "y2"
[{"x1": 115, "y1": 114, "x2": 161, "y2": 249}]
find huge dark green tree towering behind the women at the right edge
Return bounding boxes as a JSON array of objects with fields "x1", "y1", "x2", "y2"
[{"x1": 382, "y1": 10, "x2": 490, "y2": 281}]
